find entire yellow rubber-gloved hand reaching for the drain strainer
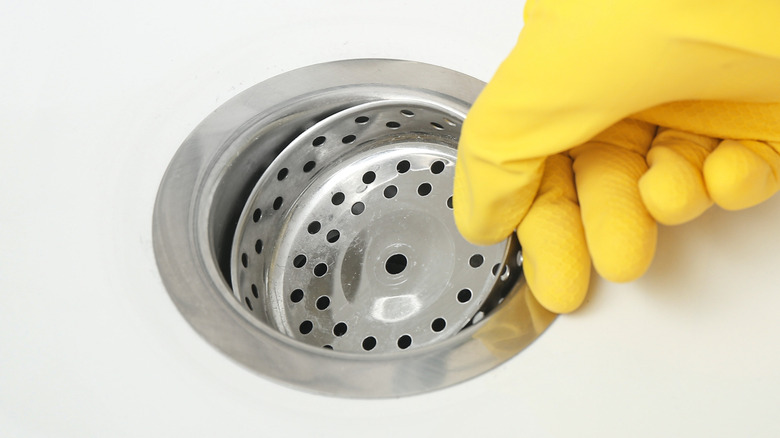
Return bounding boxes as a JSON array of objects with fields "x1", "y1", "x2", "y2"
[{"x1": 454, "y1": 0, "x2": 780, "y2": 313}]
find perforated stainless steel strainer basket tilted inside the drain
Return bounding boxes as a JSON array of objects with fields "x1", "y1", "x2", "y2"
[{"x1": 232, "y1": 100, "x2": 518, "y2": 352}]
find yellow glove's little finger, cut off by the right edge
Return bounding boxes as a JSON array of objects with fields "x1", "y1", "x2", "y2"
[{"x1": 703, "y1": 140, "x2": 780, "y2": 210}]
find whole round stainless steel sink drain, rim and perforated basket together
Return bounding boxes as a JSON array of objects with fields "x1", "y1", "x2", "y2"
[{"x1": 153, "y1": 59, "x2": 554, "y2": 397}]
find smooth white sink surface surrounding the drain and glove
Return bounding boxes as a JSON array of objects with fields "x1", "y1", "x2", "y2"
[{"x1": 0, "y1": 0, "x2": 780, "y2": 437}]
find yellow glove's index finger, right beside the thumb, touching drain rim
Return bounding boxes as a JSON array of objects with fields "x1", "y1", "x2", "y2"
[{"x1": 517, "y1": 154, "x2": 590, "y2": 313}]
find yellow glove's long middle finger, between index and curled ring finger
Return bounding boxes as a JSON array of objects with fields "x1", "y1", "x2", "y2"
[{"x1": 570, "y1": 119, "x2": 658, "y2": 282}]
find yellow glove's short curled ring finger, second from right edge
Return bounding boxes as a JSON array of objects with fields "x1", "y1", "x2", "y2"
[{"x1": 639, "y1": 129, "x2": 718, "y2": 225}]
